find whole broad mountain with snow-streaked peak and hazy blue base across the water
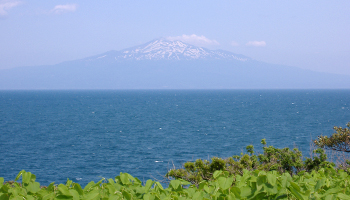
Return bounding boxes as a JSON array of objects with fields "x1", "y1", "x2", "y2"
[{"x1": 0, "y1": 38, "x2": 350, "y2": 90}]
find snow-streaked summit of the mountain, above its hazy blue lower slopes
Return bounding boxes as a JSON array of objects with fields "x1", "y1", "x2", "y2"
[{"x1": 88, "y1": 38, "x2": 250, "y2": 61}]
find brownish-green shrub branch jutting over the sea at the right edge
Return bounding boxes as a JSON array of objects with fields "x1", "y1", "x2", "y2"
[{"x1": 314, "y1": 122, "x2": 350, "y2": 152}]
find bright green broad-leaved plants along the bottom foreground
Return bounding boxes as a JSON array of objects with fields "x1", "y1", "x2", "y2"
[{"x1": 0, "y1": 168, "x2": 350, "y2": 200}]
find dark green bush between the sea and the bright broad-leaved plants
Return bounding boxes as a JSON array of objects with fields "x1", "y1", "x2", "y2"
[{"x1": 166, "y1": 139, "x2": 334, "y2": 185}]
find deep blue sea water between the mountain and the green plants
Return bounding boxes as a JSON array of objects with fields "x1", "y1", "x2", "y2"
[{"x1": 0, "y1": 90, "x2": 350, "y2": 185}]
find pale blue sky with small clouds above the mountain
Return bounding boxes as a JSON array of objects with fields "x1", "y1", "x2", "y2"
[{"x1": 0, "y1": 0, "x2": 350, "y2": 75}]
